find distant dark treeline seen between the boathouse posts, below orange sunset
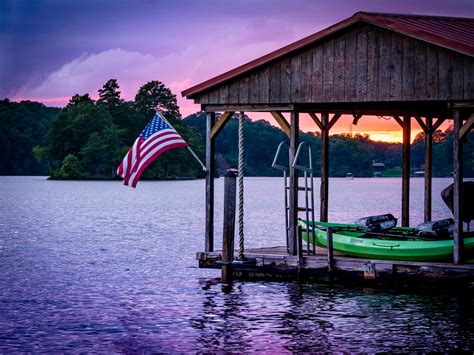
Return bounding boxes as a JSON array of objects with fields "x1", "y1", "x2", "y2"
[{"x1": 184, "y1": 112, "x2": 474, "y2": 177}]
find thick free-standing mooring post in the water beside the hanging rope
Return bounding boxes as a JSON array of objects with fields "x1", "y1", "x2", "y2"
[{"x1": 221, "y1": 169, "x2": 237, "y2": 284}]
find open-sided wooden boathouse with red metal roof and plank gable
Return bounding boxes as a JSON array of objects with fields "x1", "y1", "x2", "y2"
[{"x1": 182, "y1": 12, "x2": 474, "y2": 280}]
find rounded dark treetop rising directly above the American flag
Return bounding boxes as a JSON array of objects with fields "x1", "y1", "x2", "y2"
[{"x1": 135, "y1": 80, "x2": 181, "y2": 119}]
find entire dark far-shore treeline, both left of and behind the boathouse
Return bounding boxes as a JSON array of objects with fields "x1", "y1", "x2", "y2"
[{"x1": 0, "y1": 79, "x2": 474, "y2": 179}]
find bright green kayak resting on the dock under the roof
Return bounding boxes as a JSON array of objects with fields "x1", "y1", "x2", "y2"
[{"x1": 299, "y1": 220, "x2": 474, "y2": 261}]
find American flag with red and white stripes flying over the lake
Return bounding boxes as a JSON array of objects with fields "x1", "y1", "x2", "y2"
[{"x1": 117, "y1": 112, "x2": 187, "y2": 187}]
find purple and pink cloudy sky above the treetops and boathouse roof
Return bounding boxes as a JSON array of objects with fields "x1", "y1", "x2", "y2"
[{"x1": 0, "y1": 0, "x2": 474, "y2": 132}]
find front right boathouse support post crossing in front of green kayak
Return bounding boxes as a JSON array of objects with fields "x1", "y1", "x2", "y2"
[{"x1": 453, "y1": 110, "x2": 464, "y2": 264}]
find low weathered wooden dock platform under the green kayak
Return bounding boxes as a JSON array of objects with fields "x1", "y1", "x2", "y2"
[{"x1": 197, "y1": 247, "x2": 474, "y2": 287}]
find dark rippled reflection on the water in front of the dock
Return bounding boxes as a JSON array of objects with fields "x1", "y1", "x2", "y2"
[{"x1": 190, "y1": 280, "x2": 474, "y2": 352}]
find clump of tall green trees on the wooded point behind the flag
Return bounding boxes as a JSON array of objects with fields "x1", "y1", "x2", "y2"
[{"x1": 12, "y1": 79, "x2": 204, "y2": 179}]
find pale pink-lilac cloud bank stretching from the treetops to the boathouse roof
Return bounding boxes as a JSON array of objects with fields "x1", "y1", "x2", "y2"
[{"x1": 12, "y1": 29, "x2": 288, "y2": 115}]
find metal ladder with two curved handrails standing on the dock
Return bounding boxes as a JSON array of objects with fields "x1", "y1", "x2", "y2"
[{"x1": 272, "y1": 142, "x2": 316, "y2": 255}]
